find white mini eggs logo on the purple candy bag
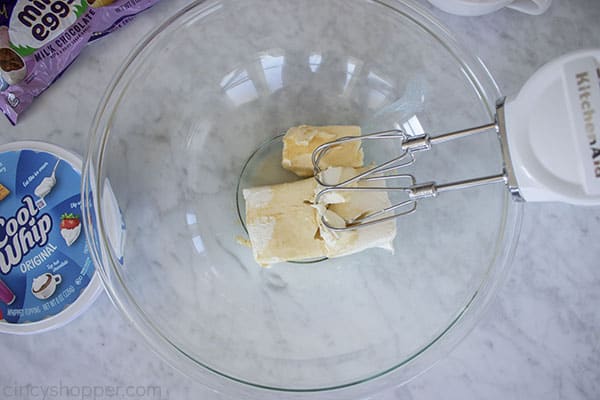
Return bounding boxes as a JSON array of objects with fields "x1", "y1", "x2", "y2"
[{"x1": 18, "y1": 0, "x2": 74, "y2": 42}]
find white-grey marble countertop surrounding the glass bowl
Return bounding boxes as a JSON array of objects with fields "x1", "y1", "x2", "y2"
[{"x1": 0, "y1": 0, "x2": 600, "y2": 400}]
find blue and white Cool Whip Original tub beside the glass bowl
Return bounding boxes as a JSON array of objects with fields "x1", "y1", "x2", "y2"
[{"x1": 0, "y1": 142, "x2": 102, "y2": 334}]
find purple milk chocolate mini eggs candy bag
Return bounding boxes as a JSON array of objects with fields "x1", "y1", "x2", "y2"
[{"x1": 0, "y1": 0, "x2": 158, "y2": 124}]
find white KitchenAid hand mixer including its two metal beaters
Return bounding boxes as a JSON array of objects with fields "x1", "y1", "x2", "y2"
[{"x1": 312, "y1": 49, "x2": 600, "y2": 231}]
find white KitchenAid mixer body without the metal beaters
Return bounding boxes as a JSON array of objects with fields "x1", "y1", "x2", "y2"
[{"x1": 500, "y1": 49, "x2": 600, "y2": 205}]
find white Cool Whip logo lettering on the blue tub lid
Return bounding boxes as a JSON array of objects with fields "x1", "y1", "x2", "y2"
[{"x1": 0, "y1": 196, "x2": 52, "y2": 274}]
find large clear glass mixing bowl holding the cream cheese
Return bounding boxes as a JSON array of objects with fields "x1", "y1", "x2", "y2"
[{"x1": 83, "y1": 0, "x2": 521, "y2": 399}]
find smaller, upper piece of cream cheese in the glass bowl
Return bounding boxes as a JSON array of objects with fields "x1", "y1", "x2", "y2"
[{"x1": 281, "y1": 125, "x2": 364, "y2": 177}]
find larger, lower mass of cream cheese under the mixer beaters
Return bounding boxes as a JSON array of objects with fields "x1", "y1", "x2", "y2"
[{"x1": 243, "y1": 167, "x2": 396, "y2": 265}]
